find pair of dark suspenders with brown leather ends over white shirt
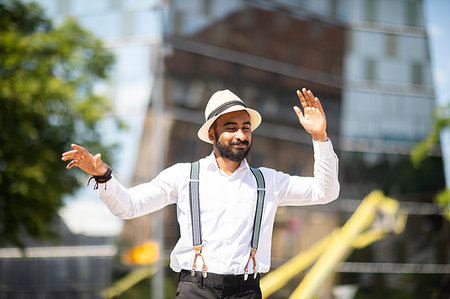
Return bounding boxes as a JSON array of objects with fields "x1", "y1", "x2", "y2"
[{"x1": 189, "y1": 161, "x2": 266, "y2": 280}]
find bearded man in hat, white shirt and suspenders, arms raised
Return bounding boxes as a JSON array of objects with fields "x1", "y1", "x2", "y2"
[{"x1": 62, "y1": 89, "x2": 339, "y2": 298}]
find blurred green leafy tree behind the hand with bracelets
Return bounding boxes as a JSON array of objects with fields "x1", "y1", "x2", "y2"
[{"x1": 0, "y1": 0, "x2": 119, "y2": 246}]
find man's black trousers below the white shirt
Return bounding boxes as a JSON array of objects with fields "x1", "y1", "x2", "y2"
[{"x1": 176, "y1": 270, "x2": 262, "y2": 299}]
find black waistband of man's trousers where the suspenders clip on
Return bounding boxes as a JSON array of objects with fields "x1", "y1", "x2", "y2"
[{"x1": 180, "y1": 270, "x2": 260, "y2": 289}]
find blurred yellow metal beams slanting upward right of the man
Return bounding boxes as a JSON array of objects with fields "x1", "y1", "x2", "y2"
[{"x1": 261, "y1": 191, "x2": 406, "y2": 299}]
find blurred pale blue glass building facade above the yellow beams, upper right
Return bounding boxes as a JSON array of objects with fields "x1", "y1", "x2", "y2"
[{"x1": 341, "y1": 0, "x2": 434, "y2": 154}]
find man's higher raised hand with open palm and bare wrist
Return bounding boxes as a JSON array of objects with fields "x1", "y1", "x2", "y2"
[{"x1": 294, "y1": 88, "x2": 328, "y2": 141}]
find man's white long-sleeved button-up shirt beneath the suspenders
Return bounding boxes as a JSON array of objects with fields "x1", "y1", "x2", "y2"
[{"x1": 98, "y1": 140, "x2": 339, "y2": 274}]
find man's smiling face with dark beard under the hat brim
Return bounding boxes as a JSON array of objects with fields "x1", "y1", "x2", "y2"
[{"x1": 209, "y1": 111, "x2": 252, "y2": 162}]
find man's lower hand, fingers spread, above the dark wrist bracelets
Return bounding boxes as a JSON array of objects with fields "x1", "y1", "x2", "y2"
[{"x1": 61, "y1": 144, "x2": 108, "y2": 176}]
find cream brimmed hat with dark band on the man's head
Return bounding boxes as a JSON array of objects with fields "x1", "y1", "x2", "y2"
[{"x1": 197, "y1": 89, "x2": 261, "y2": 143}]
